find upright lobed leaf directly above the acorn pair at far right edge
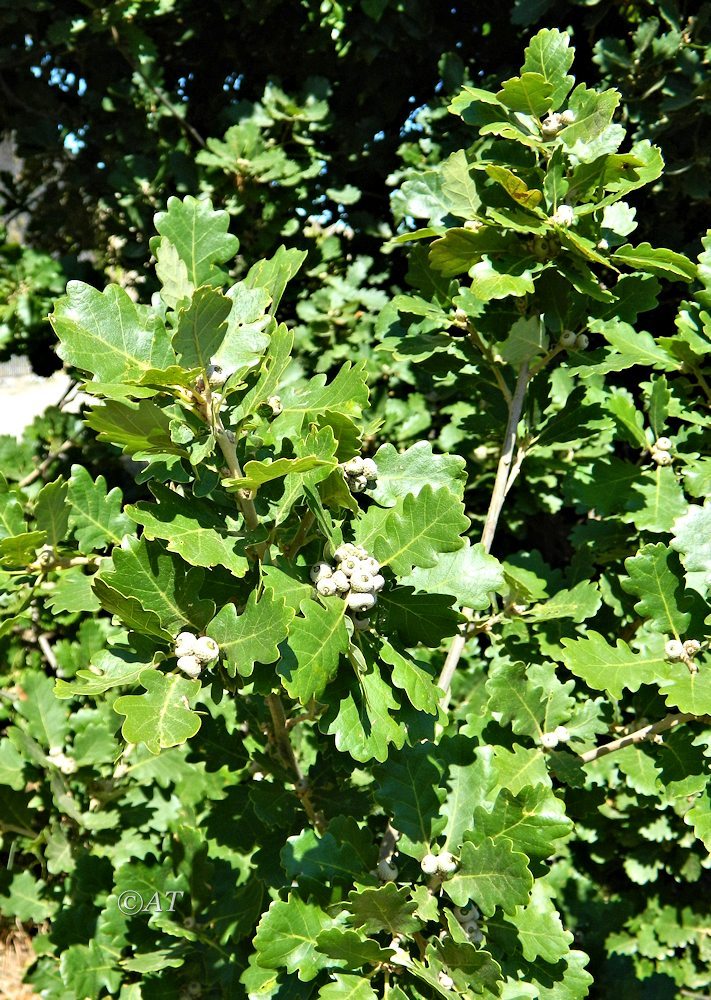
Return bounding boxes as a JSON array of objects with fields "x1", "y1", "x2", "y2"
[{"x1": 621, "y1": 542, "x2": 691, "y2": 639}]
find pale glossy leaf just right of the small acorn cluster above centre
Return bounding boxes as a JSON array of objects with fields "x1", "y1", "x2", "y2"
[{"x1": 369, "y1": 441, "x2": 466, "y2": 507}]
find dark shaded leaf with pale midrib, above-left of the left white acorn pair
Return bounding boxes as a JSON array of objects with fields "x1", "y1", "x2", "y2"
[{"x1": 94, "y1": 537, "x2": 214, "y2": 636}]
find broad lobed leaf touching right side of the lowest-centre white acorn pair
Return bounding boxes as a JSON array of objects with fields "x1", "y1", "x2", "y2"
[{"x1": 444, "y1": 837, "x2": 533, "y2": 916}]
